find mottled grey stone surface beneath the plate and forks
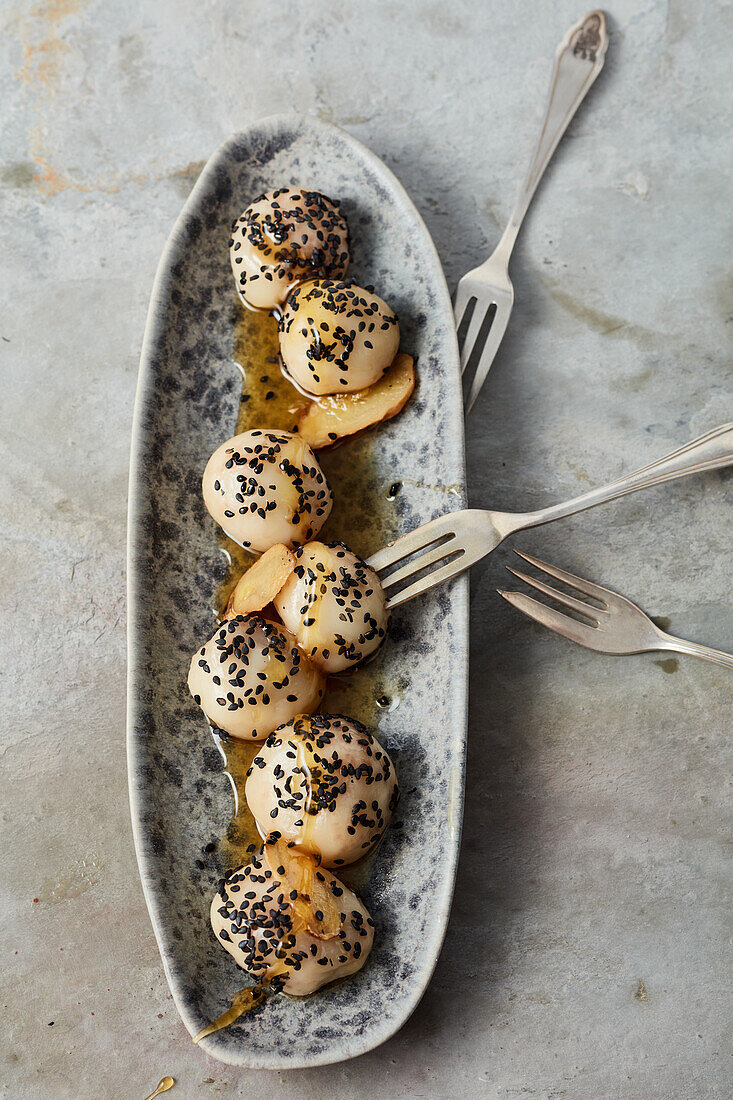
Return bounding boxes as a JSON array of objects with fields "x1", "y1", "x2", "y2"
[{"x1": 0, "y1": 0, "x2": 733, "y2": 1100}]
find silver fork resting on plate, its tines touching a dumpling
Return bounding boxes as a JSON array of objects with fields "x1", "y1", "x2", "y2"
[{"x1": 369, "y1": 424, "x2": 733, "y2": 607}]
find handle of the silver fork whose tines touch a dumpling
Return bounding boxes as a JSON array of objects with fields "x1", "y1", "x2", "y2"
[{"x1": 500, "y1": 424, "x2": 733, "y2": 535}]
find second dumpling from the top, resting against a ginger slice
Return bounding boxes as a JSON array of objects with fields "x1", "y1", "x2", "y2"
[{"x1": 278, "y1": 279, "x2": 400, "y2": 396}]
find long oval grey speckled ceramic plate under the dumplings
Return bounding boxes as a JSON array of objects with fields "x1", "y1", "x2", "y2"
[{"x1": 128, "y1": 117, "x2": 468, "y2": 1069}]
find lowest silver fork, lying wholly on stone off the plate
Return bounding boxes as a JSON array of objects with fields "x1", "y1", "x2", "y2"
[{"x1": 497, "y1": 550, "x2": 733, "y2": 669}]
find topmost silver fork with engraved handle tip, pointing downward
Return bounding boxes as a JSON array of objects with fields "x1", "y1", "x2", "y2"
[{"x1": 453, "y1": 11, "x2": 609, "y2": 413}]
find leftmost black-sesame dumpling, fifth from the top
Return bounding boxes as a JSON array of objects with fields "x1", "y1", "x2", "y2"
[{"x1": 188, "y1": 615, "x2": 325, "y2": 741}]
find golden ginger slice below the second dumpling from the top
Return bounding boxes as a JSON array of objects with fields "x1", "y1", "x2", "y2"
[{"x1": 298, "y1": 353, "x2": 415, "y2": 451}]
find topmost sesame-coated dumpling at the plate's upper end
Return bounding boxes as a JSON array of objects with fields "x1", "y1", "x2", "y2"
[{"x1": 229, "y1": 187, "x2": 349, "y2": 309}]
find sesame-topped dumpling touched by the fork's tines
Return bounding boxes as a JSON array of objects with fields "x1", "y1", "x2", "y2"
[{"x1": 274, "y1": 542, "x2": 389, "y2": 672}]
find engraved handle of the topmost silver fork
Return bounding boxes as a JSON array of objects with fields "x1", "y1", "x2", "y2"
[{"x1": 496, "y1": 11, "x2": 609, "y2": 263}]
